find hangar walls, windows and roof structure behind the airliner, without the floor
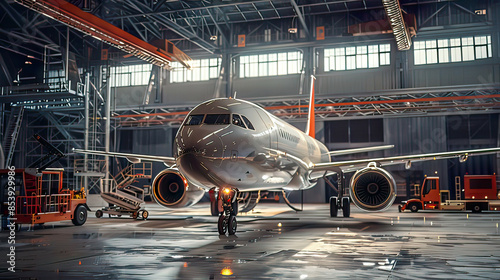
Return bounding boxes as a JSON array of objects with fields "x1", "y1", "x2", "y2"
[{"x1": 0, "y1": 0, "x2": 500, "y2": 203}]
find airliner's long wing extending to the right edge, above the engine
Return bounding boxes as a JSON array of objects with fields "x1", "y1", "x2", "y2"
[{"x1": 310, "y1": 148, "x2": 500, "y2": 172}]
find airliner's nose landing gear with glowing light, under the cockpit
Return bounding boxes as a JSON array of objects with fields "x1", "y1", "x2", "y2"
[{"x1": 215, "y1": 187, "x2": 238, "y2": 235}]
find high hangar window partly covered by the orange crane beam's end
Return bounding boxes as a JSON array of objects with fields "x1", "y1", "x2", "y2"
[{"x1": 170, "y1": 58, "x2": 221, "y2": 83}]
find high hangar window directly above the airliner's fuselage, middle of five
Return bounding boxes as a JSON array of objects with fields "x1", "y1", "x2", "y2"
[{"x1": 240, "y1": 51, "x2": 302, "y2": 78}]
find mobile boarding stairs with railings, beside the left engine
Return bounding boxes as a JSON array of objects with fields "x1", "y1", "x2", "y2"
[{"x1": 101, "y1": 162, "x2": 152, "y2": 210}]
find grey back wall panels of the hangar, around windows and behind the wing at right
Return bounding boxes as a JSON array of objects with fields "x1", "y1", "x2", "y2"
[{"x1": 112, "y1": 3, "x2": 500, "y2": 202}]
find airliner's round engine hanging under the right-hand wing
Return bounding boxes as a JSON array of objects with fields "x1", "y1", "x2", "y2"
[{"x1": 350, "y1": 163, "x2": 396, "y2": 211}]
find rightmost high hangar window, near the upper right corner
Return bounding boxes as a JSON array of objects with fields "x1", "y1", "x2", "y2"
[{"x1": 414, "y1": 35, "x2": 492, "y2": 65}]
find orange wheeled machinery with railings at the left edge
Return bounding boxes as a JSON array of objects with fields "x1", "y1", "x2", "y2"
[{"x1": 0, "y1": 168, "x2": 90, "y2": 229}]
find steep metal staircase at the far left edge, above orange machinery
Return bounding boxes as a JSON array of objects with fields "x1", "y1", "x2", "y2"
[{"x1": 2, "y1": 106, "x2": 24, "y2": 166}]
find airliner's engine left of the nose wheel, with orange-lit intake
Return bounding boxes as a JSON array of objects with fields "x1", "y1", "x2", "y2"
[{"x1": 152, "y1": 168, "x2": 205, "y2": 208}]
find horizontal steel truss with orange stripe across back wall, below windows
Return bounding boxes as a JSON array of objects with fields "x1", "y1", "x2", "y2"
[{"x1": 113, "y1": 84, "x2": 500, "y2": 126}]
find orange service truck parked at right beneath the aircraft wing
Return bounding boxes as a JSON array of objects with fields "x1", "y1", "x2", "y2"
[{"x1": 399, "y1": 175, "x2": 500, "y2": 212}]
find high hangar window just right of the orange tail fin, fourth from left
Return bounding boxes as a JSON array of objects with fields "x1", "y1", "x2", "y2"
[{"x1": 324, "y1": 44, "x2": 391, "y2": 71}]
